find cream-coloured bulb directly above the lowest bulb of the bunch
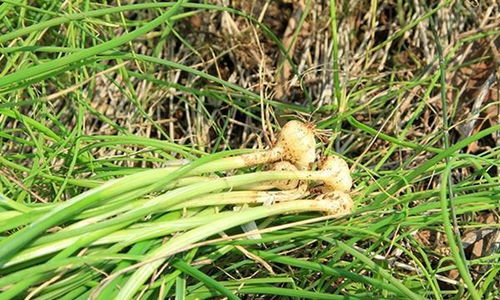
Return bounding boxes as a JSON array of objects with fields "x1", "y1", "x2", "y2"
[{"x1": 319, "y1": 155, "x2": 352, "y2": 192}]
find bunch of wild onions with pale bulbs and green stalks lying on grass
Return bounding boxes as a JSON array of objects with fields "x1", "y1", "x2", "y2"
[{"x1": 0, "y1": 121, "x2": 353, "y2": 299}]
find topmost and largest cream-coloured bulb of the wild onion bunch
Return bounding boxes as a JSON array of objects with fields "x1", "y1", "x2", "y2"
[{"x1": 273, "y1": 121, "x2": 316, "y2": 170}]
